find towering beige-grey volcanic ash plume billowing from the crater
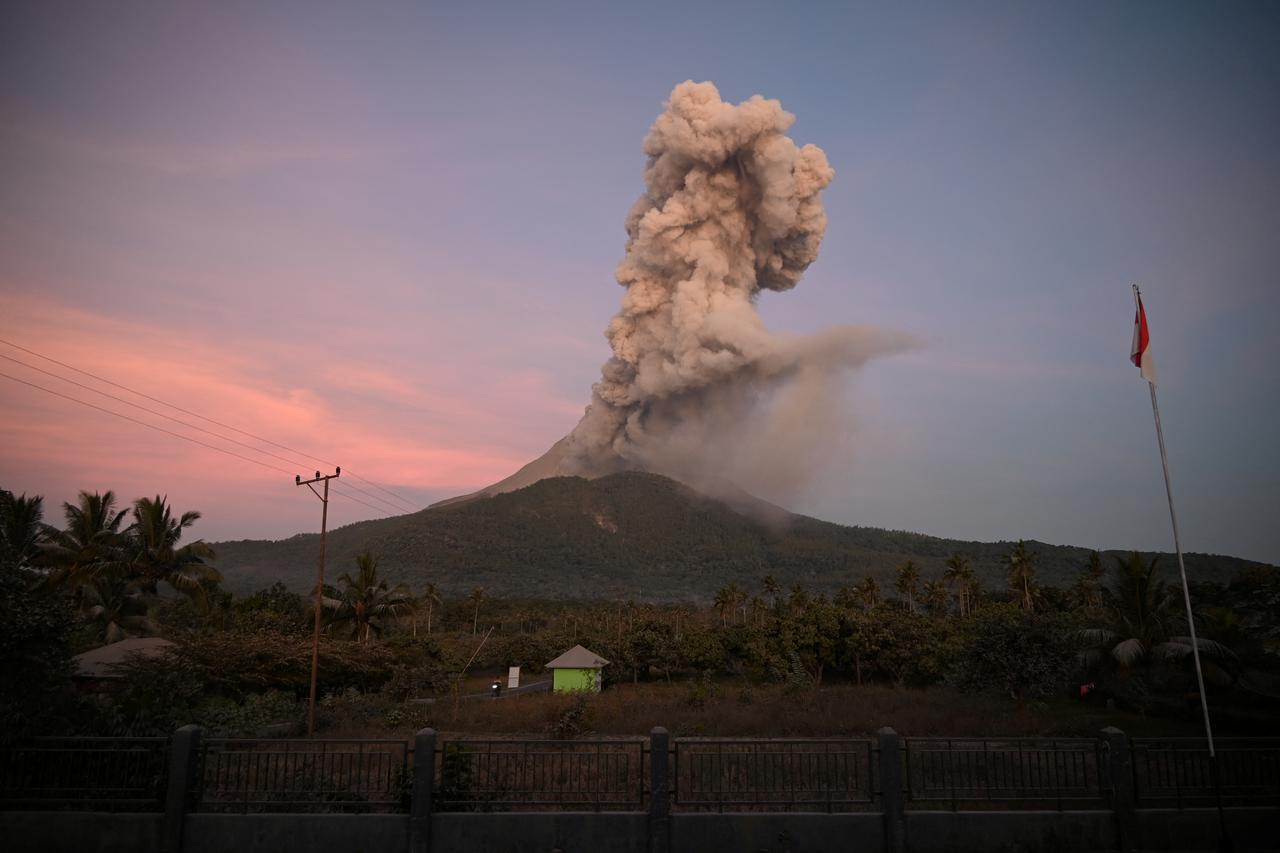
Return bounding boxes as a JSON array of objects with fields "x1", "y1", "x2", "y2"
[{"x1": 559, "y1": 82, "x2": 911, "y2": 487}]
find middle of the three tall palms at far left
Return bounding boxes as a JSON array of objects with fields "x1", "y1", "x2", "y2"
[{"x1": 42, "y1": 491, "x2": 128, "y2": 594}]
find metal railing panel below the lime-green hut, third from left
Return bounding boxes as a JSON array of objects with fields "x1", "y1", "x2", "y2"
[{"x1": 434, "y1": 738, "x2": 648, "y2": 811}]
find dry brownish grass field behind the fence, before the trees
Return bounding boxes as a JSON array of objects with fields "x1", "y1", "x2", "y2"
[{"x1": 324, "y1": 672, "x2": 1218, "y2": 736}]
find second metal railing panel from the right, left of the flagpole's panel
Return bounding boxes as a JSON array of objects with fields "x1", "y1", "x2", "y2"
[{"x1": 902, "y1": 738, "x2": 1106, "y2": 811}]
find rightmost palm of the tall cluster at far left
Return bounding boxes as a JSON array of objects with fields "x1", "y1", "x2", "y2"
[{"x1": 127, "y1": 494, "x2": 223, "y2": 601}]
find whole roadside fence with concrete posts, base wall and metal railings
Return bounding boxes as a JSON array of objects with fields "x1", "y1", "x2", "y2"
[{"x1": 0, "y1": 726, "x2": 1280, "y2": 853}]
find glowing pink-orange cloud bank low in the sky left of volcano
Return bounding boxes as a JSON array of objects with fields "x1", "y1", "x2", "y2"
[{"x1": 0, "y1": 293, "x2": 580, "y2": 535}]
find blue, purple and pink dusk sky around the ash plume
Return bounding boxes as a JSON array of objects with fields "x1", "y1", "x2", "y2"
[{"x1": 0, "y1": 1, "x2": 1280, "y2": 564}]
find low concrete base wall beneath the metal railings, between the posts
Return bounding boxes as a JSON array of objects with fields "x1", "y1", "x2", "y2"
[{"x1": 0, "y1": 808, "x2": 1280, "y2": 853}]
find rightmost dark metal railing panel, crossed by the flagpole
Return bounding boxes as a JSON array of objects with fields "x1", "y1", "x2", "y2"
[{"x1": 1132, "y1": 738, "x2": 1280, "y2": 808}]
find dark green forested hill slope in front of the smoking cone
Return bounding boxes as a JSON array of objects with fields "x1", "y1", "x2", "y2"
[{"x1": 215, "y1": 471, "x2": 1261, "y2": 601}]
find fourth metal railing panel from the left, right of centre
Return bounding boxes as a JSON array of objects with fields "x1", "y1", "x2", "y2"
[{"x1": 672, "y1": 738, "x2": 877, "y2": 812}]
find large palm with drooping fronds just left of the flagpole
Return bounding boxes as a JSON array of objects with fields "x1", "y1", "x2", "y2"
[{"x1": 1079, "y1": 551, "x2": 1231, "y2": 671}]
